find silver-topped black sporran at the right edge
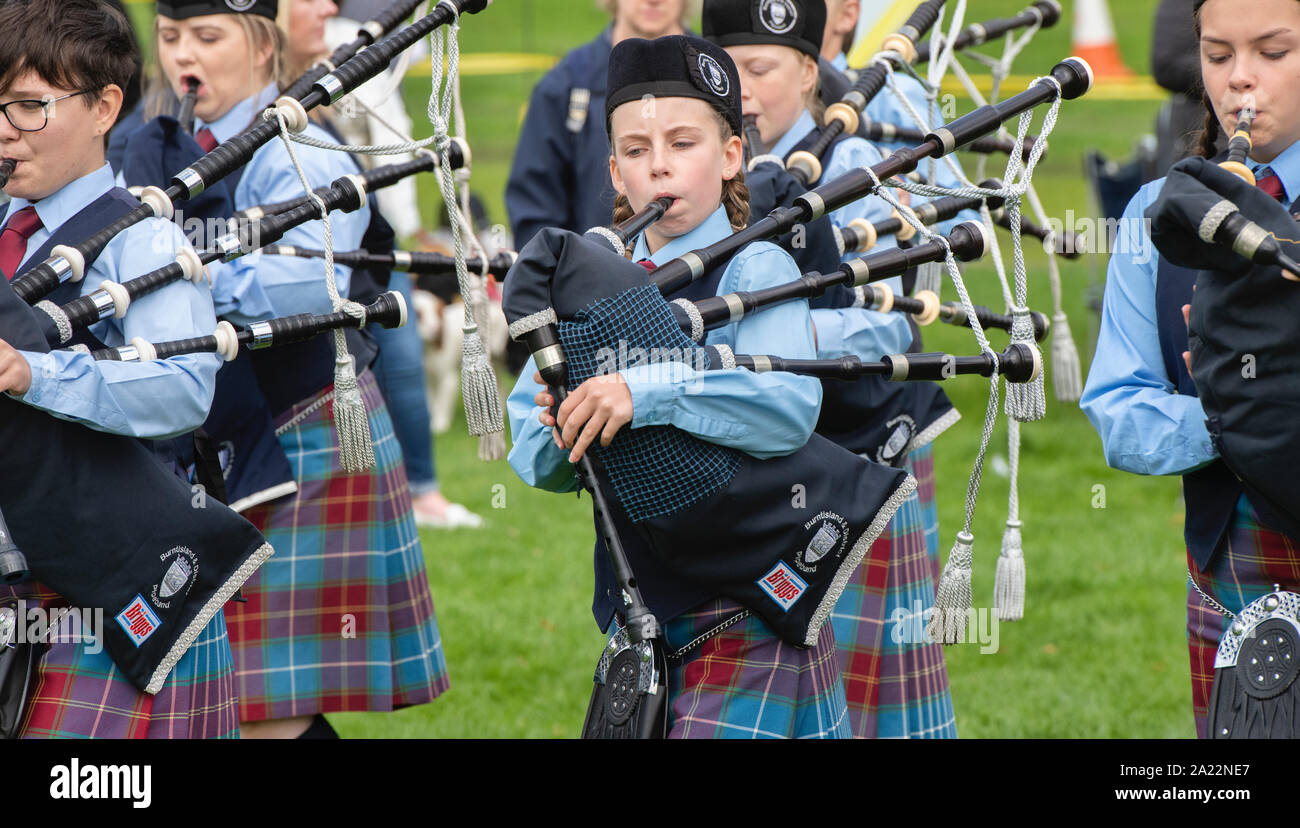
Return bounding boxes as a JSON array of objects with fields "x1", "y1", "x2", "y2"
[{"x1": 1209, "y1": 584, "x2": 1300, "y2": 738}]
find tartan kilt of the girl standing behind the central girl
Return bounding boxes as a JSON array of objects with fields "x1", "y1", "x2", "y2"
[{"x1": 831, "y1": 446, "x2": 957, "y2": 738}]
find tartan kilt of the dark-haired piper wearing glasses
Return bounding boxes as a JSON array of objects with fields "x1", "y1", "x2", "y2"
[{"x1": 0, "y1": 581, "x2": 239, "y2": 738}]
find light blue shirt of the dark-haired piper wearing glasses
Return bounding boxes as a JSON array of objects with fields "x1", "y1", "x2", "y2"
[{"x1": 5, "y1": 164, "x2": 221, "y2": 438}]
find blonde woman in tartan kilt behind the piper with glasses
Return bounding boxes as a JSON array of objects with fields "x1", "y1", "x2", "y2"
[{"x1": 139, "y1": 0, "x2": 447, "y2": 737}]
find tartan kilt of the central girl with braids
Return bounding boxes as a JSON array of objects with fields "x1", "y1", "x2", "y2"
[{"x1": 664, "y1": 598, "x2": 849, "y2": 738}]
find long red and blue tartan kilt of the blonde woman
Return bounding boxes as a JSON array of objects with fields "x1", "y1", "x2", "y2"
[{"x1": 226, "y1": 370, "x2": 447, "y2": 721}]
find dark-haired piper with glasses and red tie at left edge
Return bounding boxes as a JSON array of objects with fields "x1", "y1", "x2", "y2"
[{"x1": 0, "y1": 0, "x2": 239, "y2": 738}]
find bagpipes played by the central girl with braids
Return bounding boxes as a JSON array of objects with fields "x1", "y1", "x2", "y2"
[{"x1": 502, "y1": 58, "x2": 1091, "y2": 733}]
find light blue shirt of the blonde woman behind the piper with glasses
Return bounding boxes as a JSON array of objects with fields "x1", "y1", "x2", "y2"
[{"x1": 207, "y1": 86, "x2": 371, "y2": 325}]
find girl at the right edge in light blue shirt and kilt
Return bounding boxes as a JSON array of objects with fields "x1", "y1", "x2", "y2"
[{"x1": 1079, "y1": 0, "x2": 1300, "y2": 738}]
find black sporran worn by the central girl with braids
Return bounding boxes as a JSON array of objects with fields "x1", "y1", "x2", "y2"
[{"x1": 582, "y1": 625, "x2": 668, "y2": 738}]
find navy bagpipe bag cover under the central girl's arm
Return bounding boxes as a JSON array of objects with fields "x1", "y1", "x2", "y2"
[{"x1": 502, "y1": 229, "x2": 917, "y2": 646}]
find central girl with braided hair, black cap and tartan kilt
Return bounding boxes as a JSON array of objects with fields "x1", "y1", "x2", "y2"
[{"x1": 508, "y1": 35, "x2": 848, "y2": 738}]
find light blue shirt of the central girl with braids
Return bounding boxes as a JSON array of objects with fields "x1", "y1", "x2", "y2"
[{"x1": 507, "y1": 207, "x2": 822, "y2": 491}]
